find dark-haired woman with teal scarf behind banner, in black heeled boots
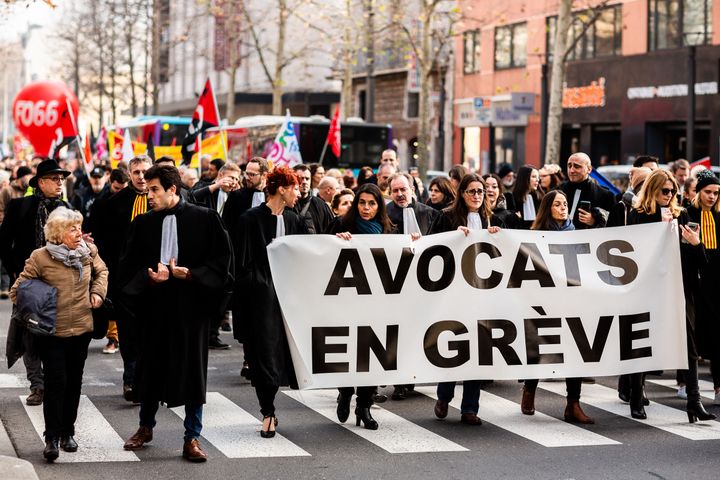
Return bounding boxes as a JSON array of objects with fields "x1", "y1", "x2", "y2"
[{"x1": 328, "y1": 183, "x2": 397, "y2": 430}]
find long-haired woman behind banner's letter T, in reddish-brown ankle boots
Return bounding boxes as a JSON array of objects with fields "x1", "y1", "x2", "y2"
[{"x1": 520, "y1": 190, "x2": 595, "y2": 425}]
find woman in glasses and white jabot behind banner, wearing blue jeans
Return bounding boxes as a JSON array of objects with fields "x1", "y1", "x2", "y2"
[{"x1": 430, "y1": 173, "x2": 502, "y2": 425}]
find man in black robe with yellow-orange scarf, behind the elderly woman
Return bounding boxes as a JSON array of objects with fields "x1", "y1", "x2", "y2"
[{"x1": 93, "y1": 155, "x2": 153, "y2": 402}]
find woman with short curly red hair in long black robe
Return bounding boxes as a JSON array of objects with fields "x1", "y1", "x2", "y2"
[{"x1": 233, "y1": 167, "x2": 307, "y2": 438}]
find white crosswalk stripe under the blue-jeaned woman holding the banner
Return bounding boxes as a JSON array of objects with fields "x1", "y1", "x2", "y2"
[{"x1": 415, "y1": 385, "x2": 620, "y2": 447}]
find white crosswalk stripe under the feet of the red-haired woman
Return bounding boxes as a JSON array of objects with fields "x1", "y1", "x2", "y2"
[{"x1": 172, "y1": 392, "x2": 310, "y2": 458}]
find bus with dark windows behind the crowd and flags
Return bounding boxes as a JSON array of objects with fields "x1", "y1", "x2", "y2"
[{"x1": 205, "y1": 115, "x2": 392, "y2": 171}]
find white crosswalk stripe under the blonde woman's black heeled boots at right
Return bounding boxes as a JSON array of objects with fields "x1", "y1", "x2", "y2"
[{"x1": 540, "y1": 382, "x2": 720, "y2": 440}]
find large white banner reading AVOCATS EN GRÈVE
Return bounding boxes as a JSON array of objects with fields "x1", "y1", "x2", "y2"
[{"x1": 268, "y1": 223, "x2": 687, "y2": 388}]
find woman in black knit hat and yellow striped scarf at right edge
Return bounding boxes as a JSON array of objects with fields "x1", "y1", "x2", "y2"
[{"x1": 687, "y1": 170, "x2": 720, "y2": 405}]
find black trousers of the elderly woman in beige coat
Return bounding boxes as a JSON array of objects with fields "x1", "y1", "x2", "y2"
[{"x1": 36, "y1": 333, "x2": 90, "y2": 438}]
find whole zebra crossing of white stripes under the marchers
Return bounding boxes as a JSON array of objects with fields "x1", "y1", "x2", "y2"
[{"x1": 5, "y1": 374, "x2": 720, "y2": 463}]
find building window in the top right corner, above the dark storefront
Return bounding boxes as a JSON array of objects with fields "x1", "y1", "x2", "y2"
[{"x1": 648, "y1": 0, "x2": 712, "y2": 50}]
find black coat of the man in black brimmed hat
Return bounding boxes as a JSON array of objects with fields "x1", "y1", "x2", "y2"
[{"x1": 0, "y1": 195, "x2": 72, "y2": 281}]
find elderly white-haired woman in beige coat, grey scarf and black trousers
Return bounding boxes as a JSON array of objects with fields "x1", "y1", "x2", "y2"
[{"x1": 10, "y1": 207, "x2": 108, "y2": 462}]
